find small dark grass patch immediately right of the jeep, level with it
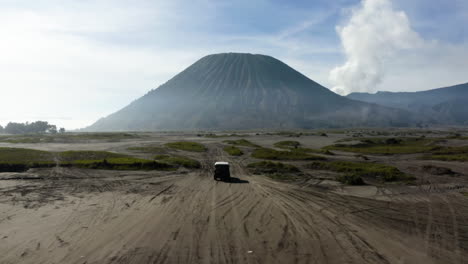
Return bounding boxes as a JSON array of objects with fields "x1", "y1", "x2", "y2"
[{"x1": 247, "y1": 161, "x2": 300, "y2": 180}]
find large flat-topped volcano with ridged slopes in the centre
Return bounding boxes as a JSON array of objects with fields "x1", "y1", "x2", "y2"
[{"x1": 86, "y1": 53, "x2": 411, "y2": 131}]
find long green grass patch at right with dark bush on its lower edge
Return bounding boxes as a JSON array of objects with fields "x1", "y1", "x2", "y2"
[{"x1": 307, "y1": 161, "x2": 414, "y2": 185}]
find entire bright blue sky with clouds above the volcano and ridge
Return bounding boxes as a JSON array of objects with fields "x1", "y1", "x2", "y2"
[{"x1": 0, "y1": 0, "x2": 468, "y2": 129}]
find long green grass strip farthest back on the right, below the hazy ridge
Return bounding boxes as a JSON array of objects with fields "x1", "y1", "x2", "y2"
[{"x1": 323, "y1": 138, "x2": 437, "y2": 155}]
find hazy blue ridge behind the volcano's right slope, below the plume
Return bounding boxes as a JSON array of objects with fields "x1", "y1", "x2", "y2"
[{"x1": 347, "y1": 83, "x2": 468, "y2": 125}]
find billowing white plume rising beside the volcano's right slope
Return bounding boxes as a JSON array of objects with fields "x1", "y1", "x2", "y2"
[{"x1": 329, "y1": 0, "x2": 422, "y2": 94}]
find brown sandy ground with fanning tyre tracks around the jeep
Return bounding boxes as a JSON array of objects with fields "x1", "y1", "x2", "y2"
[{"x1": 0, "y1": 145, "x2": 468, "y2": 264}]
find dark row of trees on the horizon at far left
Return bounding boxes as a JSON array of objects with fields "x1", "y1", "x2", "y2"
[{"x1": 0, "y1": 121, "x2": 65, "y2": 134}]
